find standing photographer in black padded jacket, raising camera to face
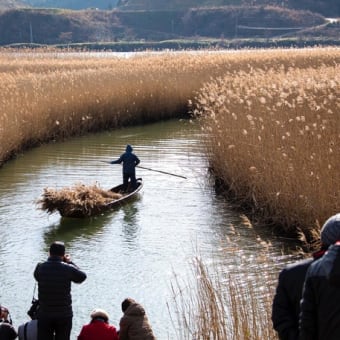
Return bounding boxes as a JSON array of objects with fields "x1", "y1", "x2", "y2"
[{"x1": 34, "y1": 241, "x2": 86, "y2": 340}]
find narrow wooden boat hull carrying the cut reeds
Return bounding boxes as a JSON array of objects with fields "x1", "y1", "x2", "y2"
[{"x1": 57, "y1": 178, "x2": 143, "y2": 218}]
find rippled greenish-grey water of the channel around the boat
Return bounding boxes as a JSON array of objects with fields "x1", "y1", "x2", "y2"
[{"x1": 0, "y1": 121, "x2": 300, "y2": 339}]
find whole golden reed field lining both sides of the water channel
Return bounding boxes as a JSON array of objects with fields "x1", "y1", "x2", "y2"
[{"x1": 0, "y1": 48, "x2": 340, "y2": 240}]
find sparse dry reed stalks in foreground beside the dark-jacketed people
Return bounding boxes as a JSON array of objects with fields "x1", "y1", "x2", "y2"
[{"x1": 170, "y1": 232, "x2": 277, "y2": 340}]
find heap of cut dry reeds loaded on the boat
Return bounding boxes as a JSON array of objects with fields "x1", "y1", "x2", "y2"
[{"x1": 38, "y1": 183, "x2": 122, "y2": 216}]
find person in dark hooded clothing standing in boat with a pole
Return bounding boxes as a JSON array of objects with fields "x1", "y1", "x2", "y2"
[{"x1": 110, "y1": 144, "x2": 140, "y2": 191}]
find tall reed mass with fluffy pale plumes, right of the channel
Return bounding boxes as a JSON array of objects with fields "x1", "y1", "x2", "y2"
[{"x1": 196, "y1": 50, "x2": 340, "y2": 242}]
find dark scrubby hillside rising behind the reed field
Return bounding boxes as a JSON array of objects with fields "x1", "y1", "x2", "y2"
[{"x1": 0, "y1": 6, "x2": 325, "y2": 45}]
